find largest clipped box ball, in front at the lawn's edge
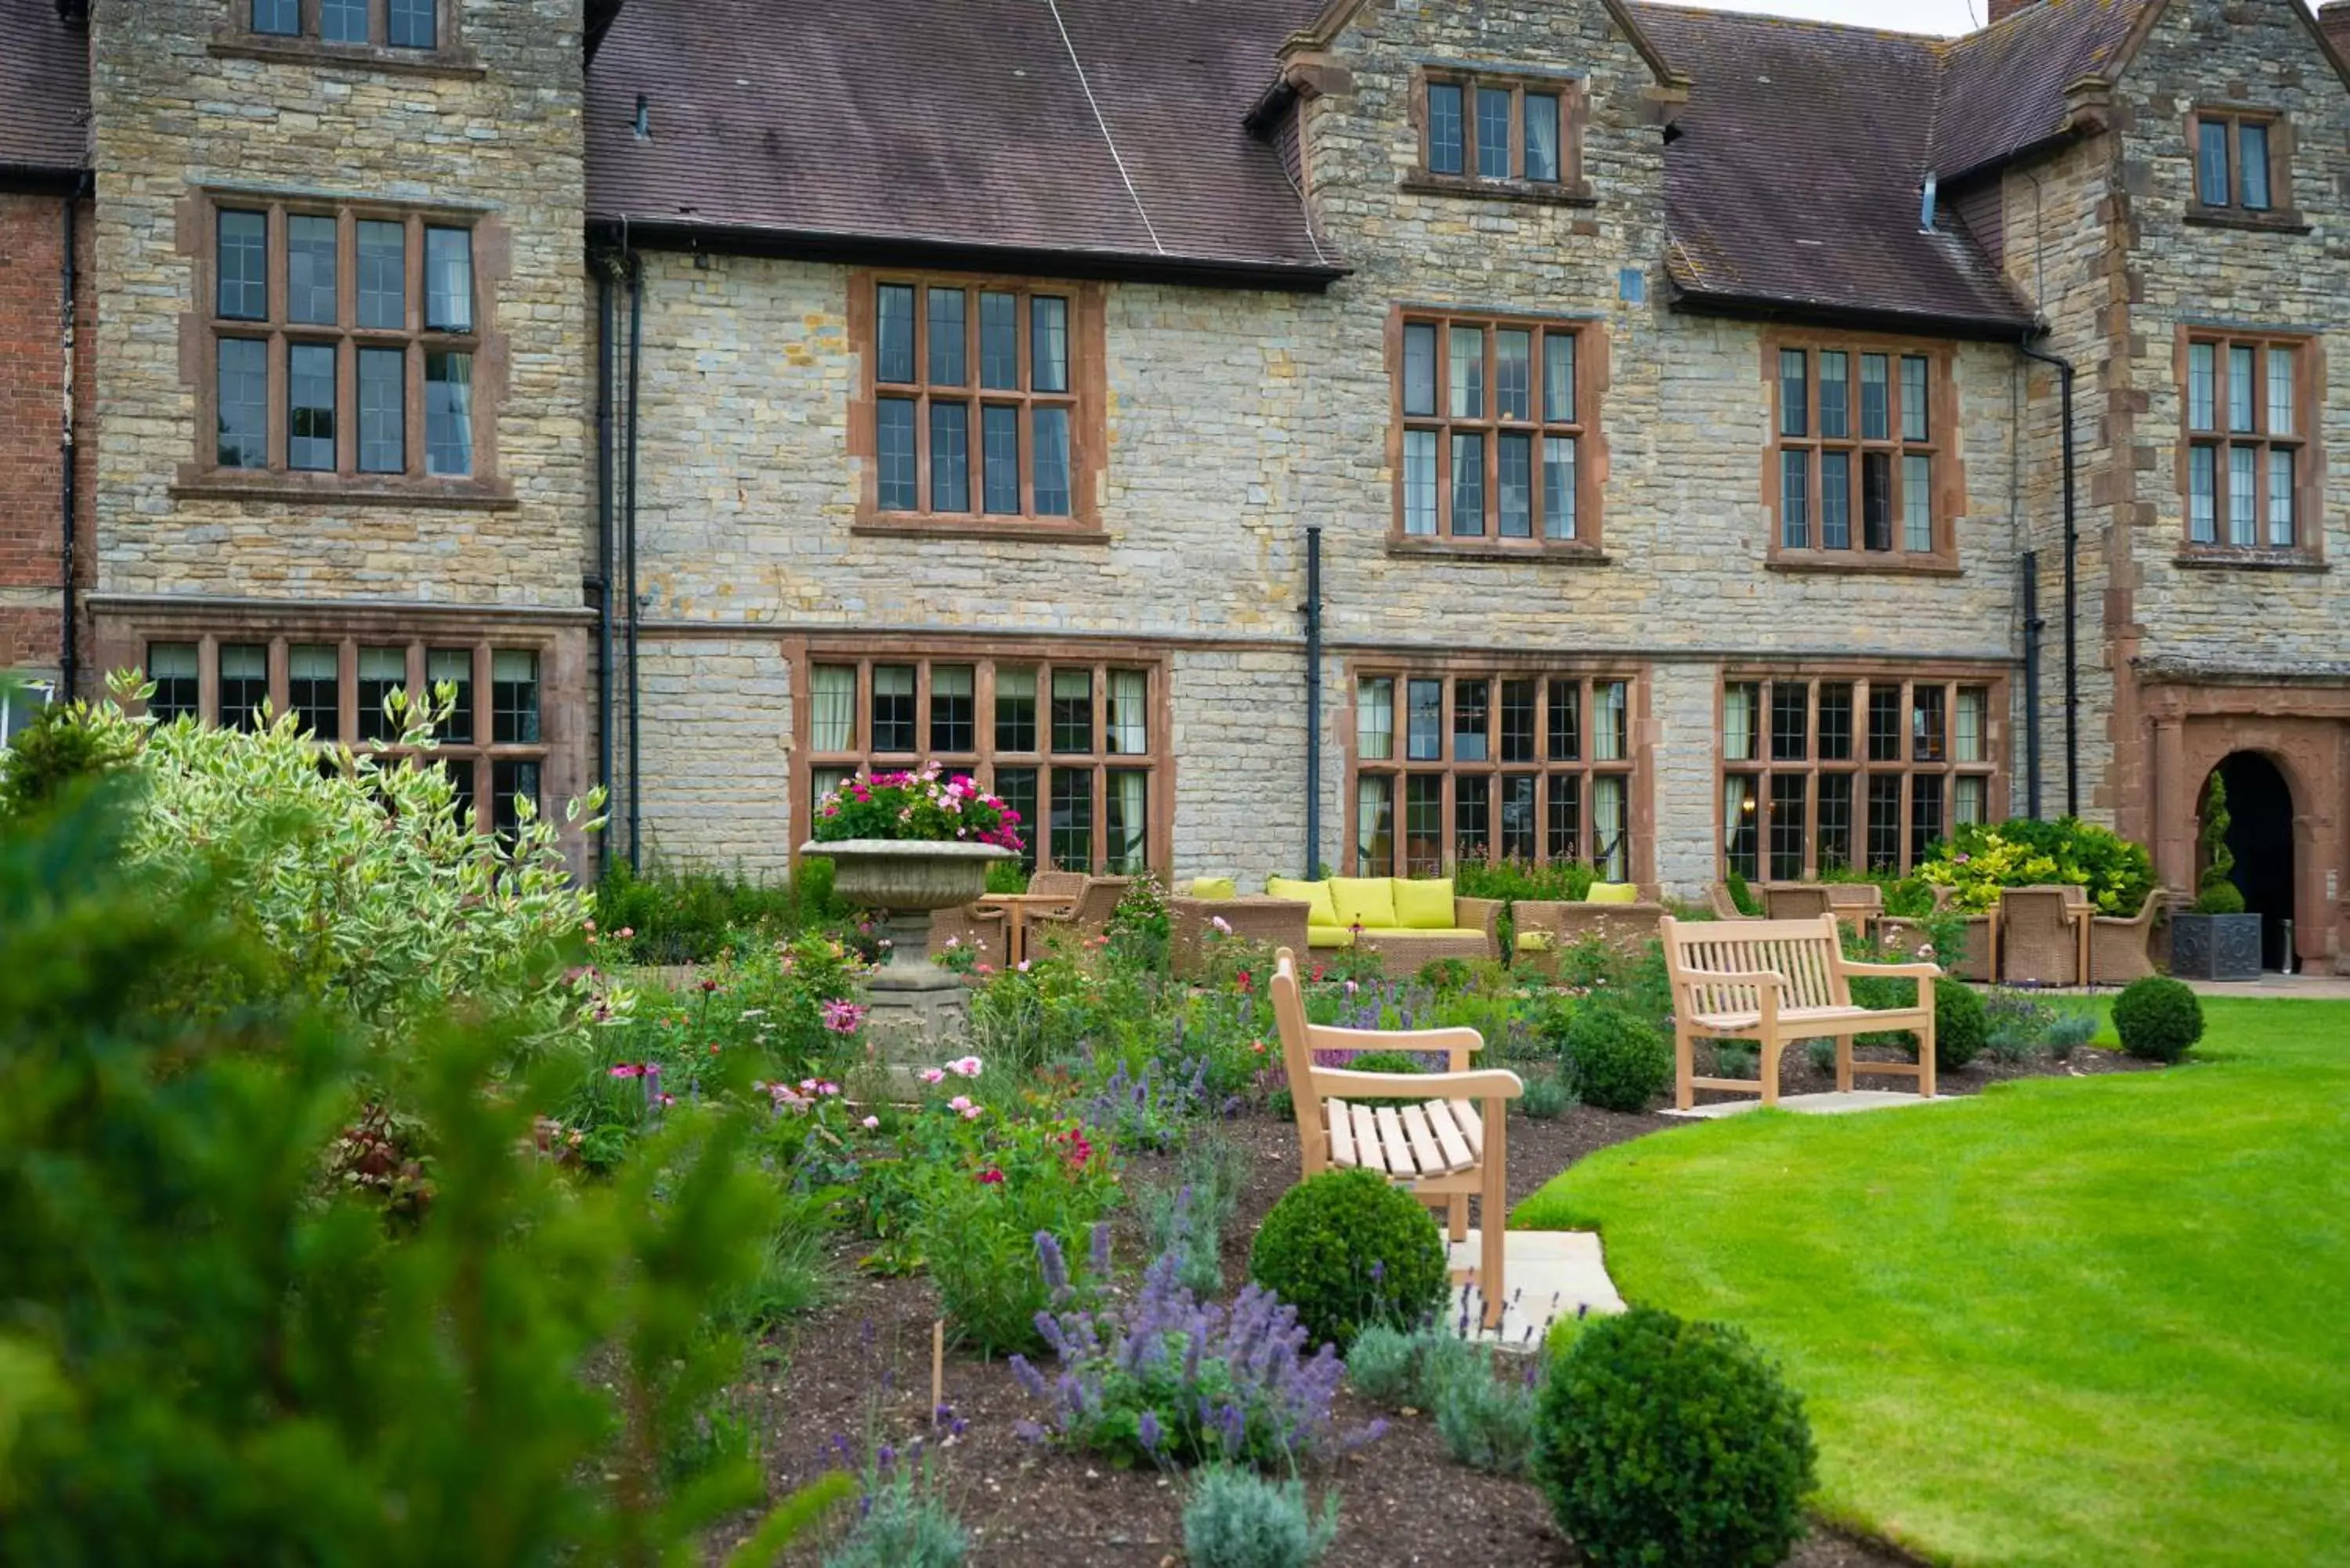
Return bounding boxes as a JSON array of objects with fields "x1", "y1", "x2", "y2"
[{"x1": 1535, "y1": 1307, "x2": 1814, "y2": 1568}]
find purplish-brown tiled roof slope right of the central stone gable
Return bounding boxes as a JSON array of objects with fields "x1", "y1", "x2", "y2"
[{"x1": 1636, "y1": 5, "x2": 2030, "y2": 331}]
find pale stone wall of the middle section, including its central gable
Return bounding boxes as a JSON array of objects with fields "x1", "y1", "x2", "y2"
[{"x1": 616, "y1": 2, "x2": 2021, "y2": 891}]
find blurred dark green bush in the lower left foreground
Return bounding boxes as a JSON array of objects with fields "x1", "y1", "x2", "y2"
[{"x1": 0, "y1": 799, "x2": 839, "y2": 1568}]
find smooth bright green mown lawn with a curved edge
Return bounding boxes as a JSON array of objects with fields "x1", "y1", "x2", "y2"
[{"x1": 1513, "y1": 1002, "x2": 2350, "y2": 1568}]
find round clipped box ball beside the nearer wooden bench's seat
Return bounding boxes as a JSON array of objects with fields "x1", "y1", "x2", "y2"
[{"x1": 1248, "y1": 1171, "x2": 1450, "y2": 1354}]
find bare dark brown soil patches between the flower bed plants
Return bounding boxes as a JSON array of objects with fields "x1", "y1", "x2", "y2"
[{"x1": 745, "y1": 1051, "x2": 2138, "y2": 1568}]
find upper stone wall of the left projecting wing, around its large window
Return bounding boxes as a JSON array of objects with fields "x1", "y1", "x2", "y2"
[{"x1": 92, "y1": 0, "x2": 595, "y2": 606}]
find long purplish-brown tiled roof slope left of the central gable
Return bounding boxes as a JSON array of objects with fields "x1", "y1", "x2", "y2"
[{"x1": 588, "y1": 0, "x2": 1337, "y2": 280}]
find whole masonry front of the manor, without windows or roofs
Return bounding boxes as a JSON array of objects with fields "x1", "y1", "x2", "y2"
[{"x1": 0, "y1": 0, "x2": 2350, "y2": 966}]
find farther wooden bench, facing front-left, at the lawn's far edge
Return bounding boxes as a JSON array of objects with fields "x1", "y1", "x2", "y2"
[{"x1": 1657, "y1": 915, "x2": 1941, "y2": 1110}]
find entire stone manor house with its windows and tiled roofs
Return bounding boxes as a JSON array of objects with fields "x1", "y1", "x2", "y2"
[{"x1": 0, "y1": 0, "x2": 2350, "y2": 969}]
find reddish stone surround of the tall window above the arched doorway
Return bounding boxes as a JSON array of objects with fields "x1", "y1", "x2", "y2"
[{"x1": 2171, "y1": 322, "x2": 2326, "y2": 571}]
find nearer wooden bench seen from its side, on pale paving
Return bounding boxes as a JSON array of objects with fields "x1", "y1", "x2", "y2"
[{"x1": 1271, "y1": 948, "x2": 1525, "y2": 1328}]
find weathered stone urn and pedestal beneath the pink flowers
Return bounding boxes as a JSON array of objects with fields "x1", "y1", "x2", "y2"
[{"x1": 799, "y1": 840, "x2": 1013, "y2": 1060}]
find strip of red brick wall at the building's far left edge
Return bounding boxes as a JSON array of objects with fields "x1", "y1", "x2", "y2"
[{"x1": 0, "y1": 193, "x2": 96, "y2": 679}]
